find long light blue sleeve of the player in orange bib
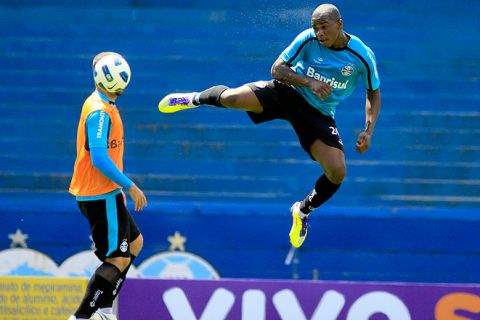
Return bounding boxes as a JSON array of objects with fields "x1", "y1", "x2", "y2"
[{"x1": 86, "y1": 111, "x2": 133, "y2": 190}]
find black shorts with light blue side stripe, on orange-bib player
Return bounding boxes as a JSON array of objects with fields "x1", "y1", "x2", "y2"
[{"x1": 77, "y1": 193, "x2": 140, "y2": 261}]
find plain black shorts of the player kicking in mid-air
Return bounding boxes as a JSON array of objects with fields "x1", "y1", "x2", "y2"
[{"x1": 247, "y1": 80, "x2": 344, "y2": 159}]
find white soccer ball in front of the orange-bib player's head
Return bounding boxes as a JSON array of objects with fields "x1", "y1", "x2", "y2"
[{"x1": 93, "y1": 54, "x2": 131, "y2": 93}]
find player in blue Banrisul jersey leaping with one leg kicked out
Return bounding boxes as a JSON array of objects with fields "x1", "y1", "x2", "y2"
[{"x1": 158, "y1": 4, "x2": 380, "y2": 248}]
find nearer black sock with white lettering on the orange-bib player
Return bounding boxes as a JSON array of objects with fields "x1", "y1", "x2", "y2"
[{"x1": 74, "y1": 262, "x2": 121, "y2": 319}]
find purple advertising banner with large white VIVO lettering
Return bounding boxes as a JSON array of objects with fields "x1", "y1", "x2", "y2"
[{"x1": 119, "y1": 279, "x2": 480, "y2": 320}]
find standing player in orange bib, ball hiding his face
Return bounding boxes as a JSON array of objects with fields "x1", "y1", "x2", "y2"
[{"x1": 69, "y1": 52, "x2": 147, "y2": 320}]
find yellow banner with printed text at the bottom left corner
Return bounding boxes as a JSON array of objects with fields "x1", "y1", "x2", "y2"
[{"x1": 0, "y1": 277, "x2": 87, "y2": 320}]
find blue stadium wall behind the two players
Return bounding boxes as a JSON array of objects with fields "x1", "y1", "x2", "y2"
[{"x1": 0, "y1": 0, "x2": 480, "y2": 282}]
